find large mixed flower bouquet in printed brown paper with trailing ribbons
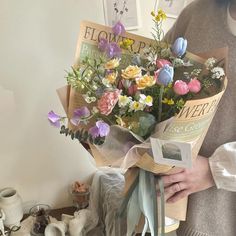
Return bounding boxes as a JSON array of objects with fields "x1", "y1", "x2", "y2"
[{"x1": 48, "y1": 10, "x2": 226, "y2": 235}]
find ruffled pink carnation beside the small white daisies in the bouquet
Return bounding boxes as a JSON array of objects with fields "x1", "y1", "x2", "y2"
[{"x1": 98, "y1": 89, "x2": 120, "y2": 116}]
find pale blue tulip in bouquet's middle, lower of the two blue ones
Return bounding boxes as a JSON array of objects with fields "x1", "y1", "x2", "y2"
[{"x1": 155, "y1": 64, "x2": 174, "y2": 86}]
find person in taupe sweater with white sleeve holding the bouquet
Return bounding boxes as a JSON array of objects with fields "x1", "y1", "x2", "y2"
[{"x1": 163, "y1": 0, "x2": 236, "y2": 236}]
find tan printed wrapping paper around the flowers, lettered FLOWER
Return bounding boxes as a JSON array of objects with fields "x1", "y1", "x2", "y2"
[{"x1": 58, "y1": 22, "x2": 227, "y2": 234}]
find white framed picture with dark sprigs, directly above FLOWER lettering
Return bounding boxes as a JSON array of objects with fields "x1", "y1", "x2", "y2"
[{"x1": 103, "y1": 0, "x2": 141, "y2": 30}]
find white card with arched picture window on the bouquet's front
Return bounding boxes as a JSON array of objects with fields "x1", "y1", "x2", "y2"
[{"x1": 150, "y1": 138, "x2": 192, "y2": 168}]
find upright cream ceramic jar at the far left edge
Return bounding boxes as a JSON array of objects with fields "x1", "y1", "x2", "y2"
[{"x1": 0, "y1": 188, "x2": 23, "y2": 229}]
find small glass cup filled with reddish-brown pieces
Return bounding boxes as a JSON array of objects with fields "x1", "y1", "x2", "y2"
[{"x1": 69, "y1": 181, "x2": 90, "y2": 210}]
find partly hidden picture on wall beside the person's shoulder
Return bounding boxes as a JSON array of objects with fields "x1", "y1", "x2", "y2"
[{"x1": 155, "y1": 0, "x2": 192, "y2": 18}]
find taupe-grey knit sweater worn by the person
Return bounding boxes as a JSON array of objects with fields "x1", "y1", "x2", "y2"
[{"x1": 167, "y1": 0, "x2": 236, "y2": 236}]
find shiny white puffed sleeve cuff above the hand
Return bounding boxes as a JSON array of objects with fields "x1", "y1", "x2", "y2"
[{"x1": 209, "y1": 142, "x2": 236, "y2": 192}]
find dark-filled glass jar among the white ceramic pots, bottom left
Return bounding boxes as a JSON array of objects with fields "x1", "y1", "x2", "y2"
[{"x1": 29, "y1": 204, "x2": 51, "y2": 236}]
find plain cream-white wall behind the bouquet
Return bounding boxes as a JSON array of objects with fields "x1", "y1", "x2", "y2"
[{"x1": 0, "y1": 0, "x2": 176, "y2": 210}]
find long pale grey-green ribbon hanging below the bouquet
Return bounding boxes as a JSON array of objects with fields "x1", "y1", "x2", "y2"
[{"x1": 118, "y1": 169, "x2": 165, "y2": 236}]
